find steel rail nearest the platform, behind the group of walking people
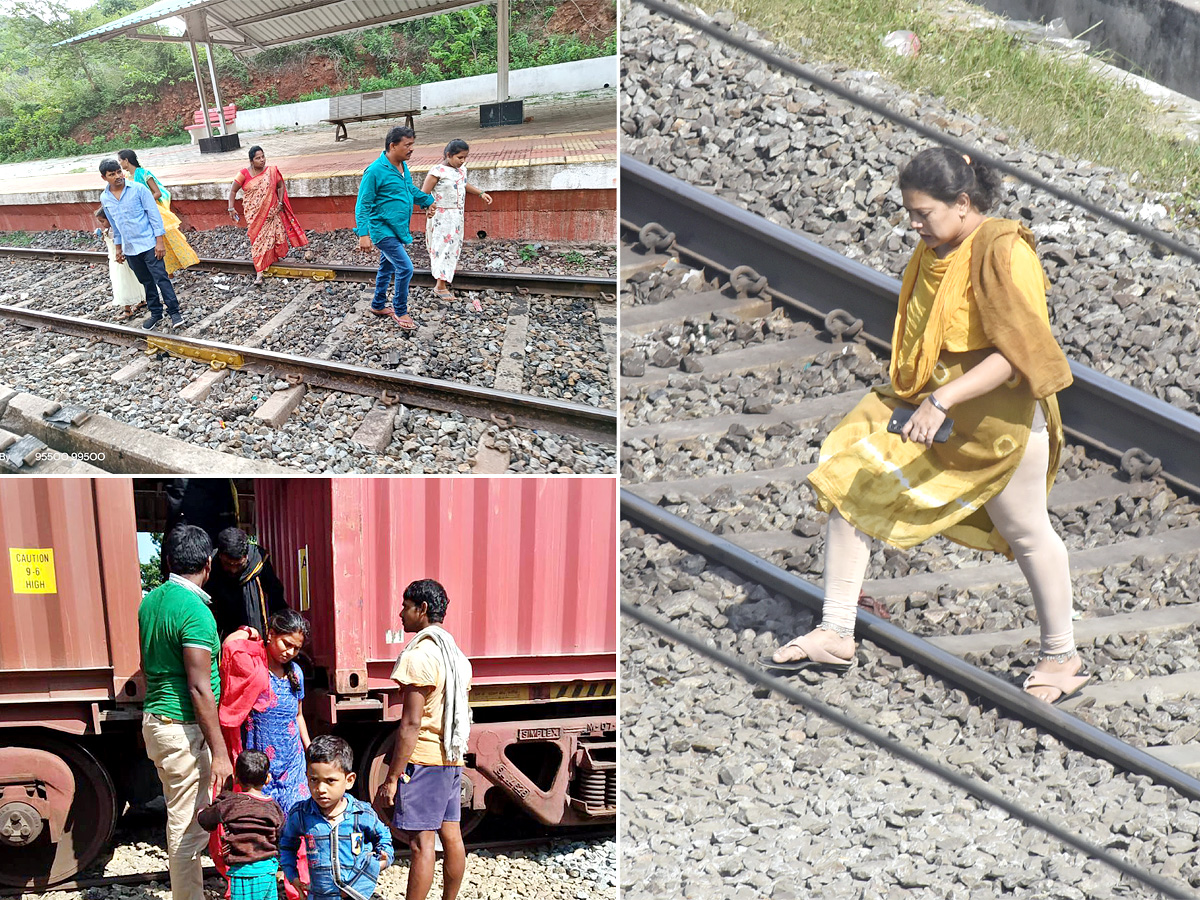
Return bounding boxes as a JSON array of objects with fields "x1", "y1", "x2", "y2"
[{"x1": 0, "y1": 246, "x2": 617, "y2": 299}]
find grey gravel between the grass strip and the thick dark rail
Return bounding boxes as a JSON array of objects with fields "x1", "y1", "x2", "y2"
[{"x1": 620, "y1": 4, "x2": 1200, "y2": 412}]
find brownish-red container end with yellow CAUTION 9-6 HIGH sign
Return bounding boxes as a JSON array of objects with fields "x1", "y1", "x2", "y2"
[{"x1": 0, "y1": 478, "x2": 142, "y2": 733}]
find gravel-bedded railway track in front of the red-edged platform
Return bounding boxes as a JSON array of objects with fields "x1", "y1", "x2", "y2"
[{"x1": 0, "y1": 243, "x2": 616, "y2": 473}]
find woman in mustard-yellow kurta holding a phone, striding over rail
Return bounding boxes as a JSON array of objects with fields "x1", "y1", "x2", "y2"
[{"x1": 764, "y1": 148, "x2": 1087, "y2": 703}]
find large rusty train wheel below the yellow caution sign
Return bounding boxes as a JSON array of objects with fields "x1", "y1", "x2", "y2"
[{"x1": 0, "y1": 737, "x2": 116, "y2": 888}]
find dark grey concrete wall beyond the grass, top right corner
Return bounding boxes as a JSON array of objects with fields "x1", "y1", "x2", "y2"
[{"x1": 979, "y1": 0, "x2": 1200, "y2": 98}]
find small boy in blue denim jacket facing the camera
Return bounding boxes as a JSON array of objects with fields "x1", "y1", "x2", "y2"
[{"x1": 280, "y1": 734, "x2": 395, "y2": 900}]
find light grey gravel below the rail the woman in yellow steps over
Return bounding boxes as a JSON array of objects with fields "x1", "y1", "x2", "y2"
[{"x1": 620, "y1": 523, "x2": 1200, "y2": 900}]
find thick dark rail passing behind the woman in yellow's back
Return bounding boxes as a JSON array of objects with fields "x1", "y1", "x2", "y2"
[{"x1": 620, "y1": 155, "x2": 1200, "y2": 496}]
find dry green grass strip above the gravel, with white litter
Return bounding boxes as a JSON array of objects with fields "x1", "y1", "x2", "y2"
[{"x1": 700, "y1": 0, "x2": 1200, "y2": 214}]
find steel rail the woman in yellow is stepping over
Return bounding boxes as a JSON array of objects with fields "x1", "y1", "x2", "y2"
[{"x1": 620, "y1": 490, "x2": 1200, "y2": 800}]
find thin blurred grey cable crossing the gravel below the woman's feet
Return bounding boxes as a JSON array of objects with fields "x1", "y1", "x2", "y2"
[{"x1": 620, "y1": 601, "x2": 1195, "y2": 900}]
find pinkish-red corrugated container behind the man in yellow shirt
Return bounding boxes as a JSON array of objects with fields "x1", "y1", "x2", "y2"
[{"x1": 254, "y1": 478, "x2": 617, "y2": 695}]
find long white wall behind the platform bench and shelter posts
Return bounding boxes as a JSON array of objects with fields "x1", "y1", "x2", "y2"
[{"x1": 238, "y1": 56, "x2": 617, "y2": 132}]
